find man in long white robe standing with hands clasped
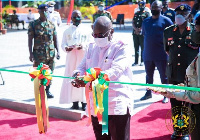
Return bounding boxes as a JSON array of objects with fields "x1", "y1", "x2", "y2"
[{"x1": 60, "y1": 10, "x2": 92, "y2": 111}]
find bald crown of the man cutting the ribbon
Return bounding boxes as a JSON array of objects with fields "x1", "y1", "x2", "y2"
[{"x1": 93, "y1": 16, "x2": 112, "y2": 31}]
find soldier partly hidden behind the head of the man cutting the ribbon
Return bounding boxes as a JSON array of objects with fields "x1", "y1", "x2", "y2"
[{"x1": 93, "y1": 2, "x2": 113, "y2": 23}]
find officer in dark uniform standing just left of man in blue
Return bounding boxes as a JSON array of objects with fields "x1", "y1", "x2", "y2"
[{"x1": 132, "y1": 1, "x2": 150, "y2": 66}]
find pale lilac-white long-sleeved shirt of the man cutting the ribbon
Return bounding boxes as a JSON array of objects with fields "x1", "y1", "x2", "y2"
[{"x1": 74, "y1": 41, "x2": 133, "y2": 115}]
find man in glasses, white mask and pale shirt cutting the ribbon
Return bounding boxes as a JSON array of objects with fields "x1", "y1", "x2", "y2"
[{"x1": 72, "y1": 16, "x2": 133, "y2": 140}]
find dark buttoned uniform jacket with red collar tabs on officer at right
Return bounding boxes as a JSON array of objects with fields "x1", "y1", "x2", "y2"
[{"x1": 164, "y1": 22, "x2": 199, "y2": 82}]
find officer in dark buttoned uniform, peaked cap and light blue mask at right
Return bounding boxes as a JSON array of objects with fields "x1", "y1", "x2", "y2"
[{"x1": 164, "y1": 4, "x2": 199, "y2": 140}]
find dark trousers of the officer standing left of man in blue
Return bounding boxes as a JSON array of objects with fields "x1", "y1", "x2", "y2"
[{"x1": 133, "y1": 34, "x2": 144, "y2": 64}]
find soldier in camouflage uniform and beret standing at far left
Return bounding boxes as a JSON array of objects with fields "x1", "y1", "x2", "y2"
[{"x1": 28, "y1": 4, "x2": 60, "y2": 98}]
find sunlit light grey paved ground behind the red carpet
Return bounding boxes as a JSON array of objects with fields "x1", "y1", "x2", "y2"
[{"x1": 0, "y1": 22, "x2": 166, "y2": 119}]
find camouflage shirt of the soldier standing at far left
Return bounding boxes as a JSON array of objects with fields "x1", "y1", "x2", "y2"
[{"x1": 28, "y1": 19, "x2": 57, "y2": 62}]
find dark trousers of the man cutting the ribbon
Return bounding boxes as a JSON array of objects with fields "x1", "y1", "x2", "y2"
[{"x1": 92, "y1": 111, "x2": 131, "y2": 140}]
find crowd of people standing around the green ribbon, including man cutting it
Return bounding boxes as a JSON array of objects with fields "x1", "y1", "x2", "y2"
[{"x1": 25, "y1": 0, "x2": 200, "y2": 140}]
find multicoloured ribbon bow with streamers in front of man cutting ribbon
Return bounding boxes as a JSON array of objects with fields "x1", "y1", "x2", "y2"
[{"x1": 83, "y1": 68, "x2": 109, "y2": 134}]
